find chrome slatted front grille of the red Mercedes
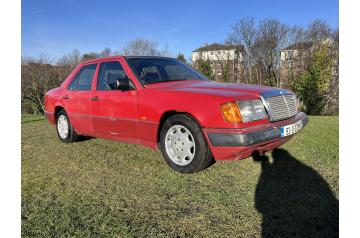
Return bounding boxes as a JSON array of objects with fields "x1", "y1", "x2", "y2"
[{"x1": 266, "y1": 95, "x2": 297, "y2": 121}]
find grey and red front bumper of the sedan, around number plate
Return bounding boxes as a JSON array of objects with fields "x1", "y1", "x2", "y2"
[{"x1": 203, "y1": 112, "x2": 308, "y2": 160}]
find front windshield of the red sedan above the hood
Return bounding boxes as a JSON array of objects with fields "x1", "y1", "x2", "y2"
[{"x1": 126, "y1": 57, "x2": 208, "y2": 85}]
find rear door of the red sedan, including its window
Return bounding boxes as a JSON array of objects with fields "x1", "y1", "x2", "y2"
[{"x1": 62, "y1": 64, "x2": 98, "y2": 135}]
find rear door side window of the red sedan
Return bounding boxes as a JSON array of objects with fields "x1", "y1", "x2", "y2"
[{"x1": 68, "y1": 64, "x2": 97, "y2": 91}]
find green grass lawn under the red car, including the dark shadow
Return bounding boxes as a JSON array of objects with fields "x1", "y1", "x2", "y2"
[{"x1": 21, "y1": 115, "x2": 339, "y2": 237}]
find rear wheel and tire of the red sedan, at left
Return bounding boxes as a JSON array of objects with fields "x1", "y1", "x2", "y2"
[{"x1": 56, "y1": 110, "x2": 79, "y2": 143}]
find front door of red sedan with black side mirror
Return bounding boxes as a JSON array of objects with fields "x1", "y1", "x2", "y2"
[{"x1": 91, "y1": 61, "x2": 137, "y2": 142}]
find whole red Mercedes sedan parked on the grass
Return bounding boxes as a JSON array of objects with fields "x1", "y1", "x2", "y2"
[{"x1": 45, "y1": 56, "x2": 308, "y2": 173}]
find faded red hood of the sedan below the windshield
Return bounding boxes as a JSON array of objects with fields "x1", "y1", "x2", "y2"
[{"x1": 146, "y1": 80, "x2": 291, "y2": 99}]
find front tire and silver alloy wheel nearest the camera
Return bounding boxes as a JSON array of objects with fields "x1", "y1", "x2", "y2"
[{"x1": 160, "y1": 114, "x2": 215, "y2": 173}]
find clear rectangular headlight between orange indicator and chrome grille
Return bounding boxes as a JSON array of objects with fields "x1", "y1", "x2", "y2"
[{"x1": 237, "y1": 99, "x2": 268, "y2": 122}]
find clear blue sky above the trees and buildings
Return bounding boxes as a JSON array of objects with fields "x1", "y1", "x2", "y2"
[{"x1": 21, "y1": 0, "x2": 339, "y2": 59}]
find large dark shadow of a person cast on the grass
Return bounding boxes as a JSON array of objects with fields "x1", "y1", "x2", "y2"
[{"x1": 254, "y1": 149, "x2": 339, "y2": 238}]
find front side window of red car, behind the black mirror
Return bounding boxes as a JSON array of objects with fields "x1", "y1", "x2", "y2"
[{"x1": 96, "y1": 61, "x2": 135, "y2": 91}]
